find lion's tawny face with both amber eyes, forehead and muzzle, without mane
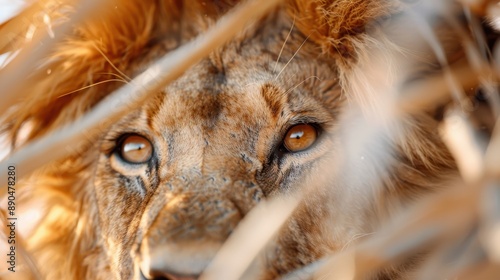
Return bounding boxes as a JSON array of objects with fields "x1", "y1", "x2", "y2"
[{"x1": 95, "y1": 14, "x2": 342, "y2": 278}]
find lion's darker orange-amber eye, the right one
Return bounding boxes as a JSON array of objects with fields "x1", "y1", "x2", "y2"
[{"x1": 283, "y1": 124, "x2": 318, "y2": 153}]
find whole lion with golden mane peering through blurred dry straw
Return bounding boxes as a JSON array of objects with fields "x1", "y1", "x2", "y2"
[{"x1": 2, "y1": 0, "x2": 492, "y2": 280}]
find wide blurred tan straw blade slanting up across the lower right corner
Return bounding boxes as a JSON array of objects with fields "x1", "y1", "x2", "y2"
[{"x1": 313, "y1": 184, "x2": 478, "y2": 279}]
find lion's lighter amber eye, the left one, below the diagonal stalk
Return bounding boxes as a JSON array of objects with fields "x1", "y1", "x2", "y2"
[{"x1": 119, "y1": 135, "x2": 153, "y2": 163}]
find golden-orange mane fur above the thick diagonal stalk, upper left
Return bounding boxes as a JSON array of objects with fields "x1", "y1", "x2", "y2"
[{"x1": 0, "y1": 0, "x2": 182, "y2": 147}]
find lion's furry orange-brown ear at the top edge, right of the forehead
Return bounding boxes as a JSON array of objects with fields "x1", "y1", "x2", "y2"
[{"x1": 287, "y1": 0, "x2": 401, "y2": 58}]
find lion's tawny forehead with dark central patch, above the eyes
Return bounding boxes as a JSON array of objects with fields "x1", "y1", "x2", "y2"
[{"x1": 150, "y1": 42, "x2": 340, "y2": 129}]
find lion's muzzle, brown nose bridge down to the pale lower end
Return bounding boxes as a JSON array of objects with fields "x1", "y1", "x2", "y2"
[{"x1": 140, "y1": 175, "x2": 250, "y2": 279}]
